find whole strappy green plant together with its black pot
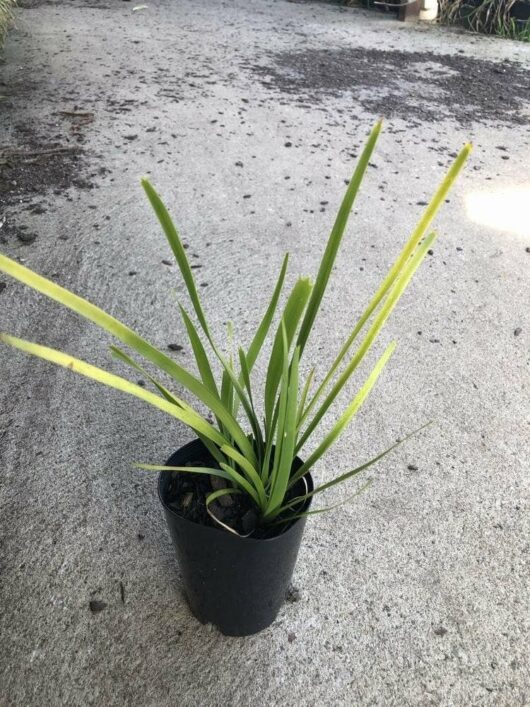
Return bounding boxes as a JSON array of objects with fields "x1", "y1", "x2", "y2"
[{"x1": 0, "y1": 121, "x2": 471, "y2": 635}]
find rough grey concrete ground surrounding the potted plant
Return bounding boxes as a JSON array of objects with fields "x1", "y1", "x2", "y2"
[{"x1": 0, "y1": 0, "x2": 530, "y2": 707}]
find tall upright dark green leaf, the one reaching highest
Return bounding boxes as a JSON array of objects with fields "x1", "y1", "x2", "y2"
[{"x1": 297, "y1": 120, "x2": 383, "y2": 356}]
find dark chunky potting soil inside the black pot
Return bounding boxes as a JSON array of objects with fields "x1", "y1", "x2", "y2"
[{"x1": 164, "y1": 459, "x2": 306, "y2": 539}]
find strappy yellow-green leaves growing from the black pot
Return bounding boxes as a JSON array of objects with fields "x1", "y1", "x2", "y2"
[{"x1": 0, "y1": 121, "x2": 471, "y2": 525}]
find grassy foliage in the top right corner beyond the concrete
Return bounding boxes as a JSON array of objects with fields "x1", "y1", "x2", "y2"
[{"x1": 438, "y1": 0, "x2": 530, "y2": 41}]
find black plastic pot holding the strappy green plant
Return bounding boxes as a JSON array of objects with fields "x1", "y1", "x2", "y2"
[{"x1": 158, "y1": 440, "x2": 313, "y2": 636}]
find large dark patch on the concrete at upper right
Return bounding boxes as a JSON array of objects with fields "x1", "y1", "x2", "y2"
[{"x1": 246, "y1": 47, "x2": 530, "y2": 125}]
